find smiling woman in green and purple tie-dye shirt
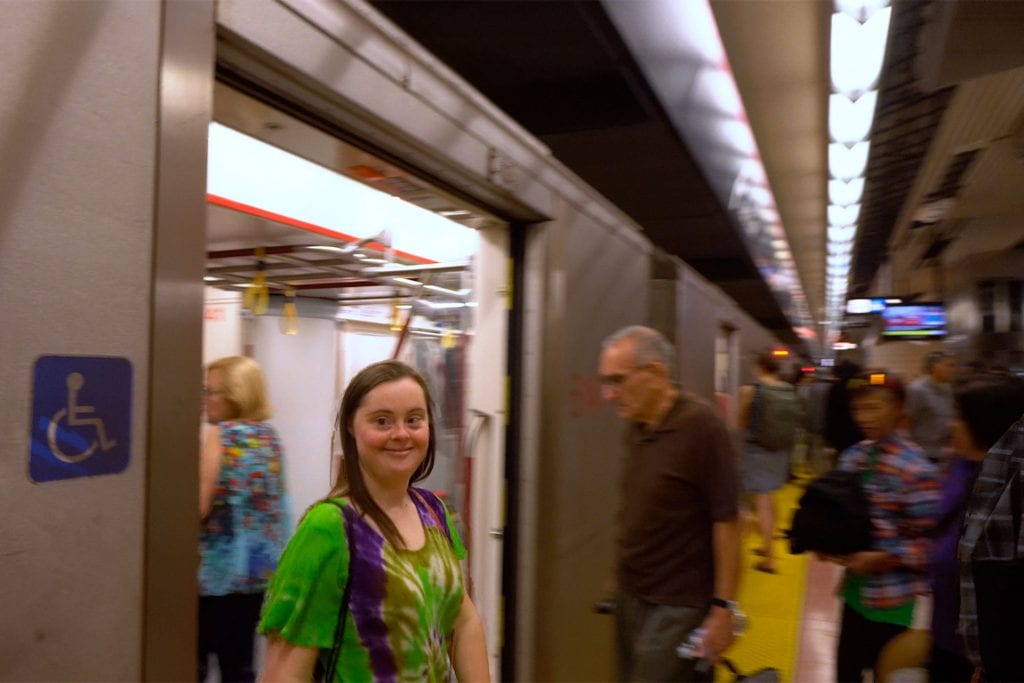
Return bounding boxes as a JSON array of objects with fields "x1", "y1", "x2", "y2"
[{"x1": 260, "y1": 360, "x2": 489, "y2": 683}]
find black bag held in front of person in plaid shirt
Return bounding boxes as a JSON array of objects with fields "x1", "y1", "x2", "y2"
[{"x1": 786, "y1": 470, "x2": 874, "y2": 555}]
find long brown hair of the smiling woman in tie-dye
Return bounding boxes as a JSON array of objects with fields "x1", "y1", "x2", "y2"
[{"x1": 331, "y1": 360, "x2": 437, "y2": 548}]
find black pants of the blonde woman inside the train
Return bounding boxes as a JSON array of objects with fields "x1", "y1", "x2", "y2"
[{"x1": 198, "y1": 593, "x2": 263, "y2": 683}]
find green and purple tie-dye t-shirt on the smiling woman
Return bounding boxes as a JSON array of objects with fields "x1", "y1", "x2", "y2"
[{"x1": 259, "y1": 489, "x2": 466, "y2": 683}]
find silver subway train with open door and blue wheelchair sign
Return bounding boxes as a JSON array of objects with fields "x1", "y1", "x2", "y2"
[{"x1": 0, "y1": 0, "x2": 1024, "y2": 681}]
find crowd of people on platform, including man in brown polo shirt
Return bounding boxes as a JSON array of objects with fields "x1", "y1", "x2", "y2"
[{"x1": 598, "y1": 326, "x2": 1024, "y2": 682}]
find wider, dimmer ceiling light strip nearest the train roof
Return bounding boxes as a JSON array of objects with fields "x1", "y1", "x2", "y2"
[{"x1": 601, "y1": 0, "x2": 813, "y2": 348}]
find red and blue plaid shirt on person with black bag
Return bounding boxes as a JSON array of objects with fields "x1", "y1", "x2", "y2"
[{"x1": 839, "y1": 433, "x2": 940, "y2": 609}]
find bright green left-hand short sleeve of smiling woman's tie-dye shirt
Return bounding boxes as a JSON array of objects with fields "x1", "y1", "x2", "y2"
[{"x1": 259, "y1": 503, "x2": 348, "y2": 648}]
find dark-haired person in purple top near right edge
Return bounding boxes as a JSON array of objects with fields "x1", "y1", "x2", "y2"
[{"x1": 929, "y1": 375, "x2": 1024, "y2": 682}]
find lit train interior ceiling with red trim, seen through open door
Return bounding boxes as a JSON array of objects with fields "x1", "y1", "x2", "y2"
[{"x1": 206, "y1": 83, "x2": 494, "y2": 321}]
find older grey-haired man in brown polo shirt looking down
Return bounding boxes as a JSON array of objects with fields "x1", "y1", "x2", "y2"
[{"x1": 599, "y1": 326, "x2": 739, "y2": 681}]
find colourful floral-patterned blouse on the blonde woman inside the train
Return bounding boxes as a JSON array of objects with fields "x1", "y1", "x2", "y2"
[{"x1": 199, "y1": 422, "x2": 289, "y2": 595}]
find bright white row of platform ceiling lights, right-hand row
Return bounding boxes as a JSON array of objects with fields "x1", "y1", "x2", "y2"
[{"x1": 824, "y1": 0, "x2": 892, "y2": 342}]
